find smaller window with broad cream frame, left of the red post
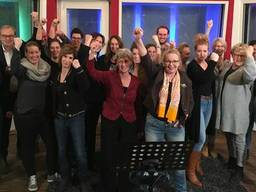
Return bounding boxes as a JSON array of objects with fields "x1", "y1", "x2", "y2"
[{"x1": 58, "y1": 0, "x2": 109, "y2": 41}]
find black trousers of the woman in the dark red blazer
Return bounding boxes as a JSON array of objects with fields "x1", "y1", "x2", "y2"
[{"x1": 101, "y1": 116, "x2": 137, "y2": 192}]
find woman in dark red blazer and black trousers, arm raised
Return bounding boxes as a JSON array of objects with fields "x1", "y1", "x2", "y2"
[{"x1": 87, "y1": 42, "x2": 140, "y2": 192}]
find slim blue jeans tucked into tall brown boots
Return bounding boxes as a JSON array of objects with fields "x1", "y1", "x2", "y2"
[{"x1": 193, "y1": 99, "x2": 212, "y2": 152}]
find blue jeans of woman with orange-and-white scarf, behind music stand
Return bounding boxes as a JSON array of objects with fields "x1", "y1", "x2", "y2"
[{"x1": 145, "y1": 114, "x2": 187, "y2": 192}]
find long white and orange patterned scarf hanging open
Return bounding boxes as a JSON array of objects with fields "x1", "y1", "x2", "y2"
[{"x1": 157, "y1": 72, "x2": 180, "y2": 123}]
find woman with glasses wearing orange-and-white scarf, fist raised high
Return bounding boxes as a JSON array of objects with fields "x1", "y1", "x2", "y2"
[{"x1": 134, "y1": 28, "x2": 193, "y2": 192}]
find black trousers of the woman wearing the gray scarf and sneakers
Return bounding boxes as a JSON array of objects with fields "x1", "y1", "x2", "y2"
[{"x1": 14, "y1": 113, "x2": 57, "y2": 176}]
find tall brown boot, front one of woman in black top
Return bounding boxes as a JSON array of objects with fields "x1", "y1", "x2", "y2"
[{"x1": 187, "y1": 151, "x2": 203, "y2": 188}]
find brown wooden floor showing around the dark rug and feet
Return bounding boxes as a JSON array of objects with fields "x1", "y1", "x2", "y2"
[{"x1": 0, "y1": 132, "x2": 256, "y2": 192}]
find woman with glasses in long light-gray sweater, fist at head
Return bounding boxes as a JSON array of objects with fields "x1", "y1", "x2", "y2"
[{"x1": 216, "y1": 43, "x2": 256, "y2": 183}]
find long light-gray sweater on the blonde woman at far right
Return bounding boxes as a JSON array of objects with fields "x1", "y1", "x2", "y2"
[{"x1": 216, "y1": 57, "x2": 256, "y2": 134}]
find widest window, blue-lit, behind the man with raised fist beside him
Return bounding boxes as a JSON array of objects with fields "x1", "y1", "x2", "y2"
[{"x1": 122, "y1": 2, "x2": 224, "y2": 47}]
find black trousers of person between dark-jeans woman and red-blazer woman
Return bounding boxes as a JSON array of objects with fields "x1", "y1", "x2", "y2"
[{"x1": 85, "y1": 103, "x2": 102, "y2": 170}]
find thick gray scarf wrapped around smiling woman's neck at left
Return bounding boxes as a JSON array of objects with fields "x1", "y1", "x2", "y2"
[{"x1": 21, "y1": 58, "x2": 51, "y2": 82}]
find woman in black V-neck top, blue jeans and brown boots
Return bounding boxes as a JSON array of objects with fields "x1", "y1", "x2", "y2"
[{"x1": 186, "y1": 34, "x2": 219, "y2": 188}]
